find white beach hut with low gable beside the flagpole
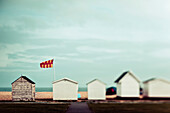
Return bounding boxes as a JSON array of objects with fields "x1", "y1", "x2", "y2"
[{"x1": 53, "y1": 78, "x2": 78, "y2": 100}]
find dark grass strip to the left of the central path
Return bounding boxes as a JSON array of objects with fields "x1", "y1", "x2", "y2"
[{"x1": 0, "y1": 103, "x2": 69, "y2": 113}]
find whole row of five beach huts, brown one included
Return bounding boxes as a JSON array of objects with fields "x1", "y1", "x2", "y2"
[{"x1": 12, "y1": 71, "x2": 170, "y2": 101}]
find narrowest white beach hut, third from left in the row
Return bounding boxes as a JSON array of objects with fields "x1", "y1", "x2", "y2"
[{"x1": 86, "y1": 79, "x2": 106, "y2": 100}]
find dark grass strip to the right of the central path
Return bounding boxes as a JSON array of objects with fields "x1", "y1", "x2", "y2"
[{"x1": 88, "y1": 103, "x2": 170, "y2": 113}]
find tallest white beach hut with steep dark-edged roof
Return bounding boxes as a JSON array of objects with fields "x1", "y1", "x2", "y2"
[{"x1": 115, "y1": 71, "x2": 140, "y2": 97}]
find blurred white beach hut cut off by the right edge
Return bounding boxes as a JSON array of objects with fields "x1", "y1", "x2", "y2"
[{"x1": 143, "y1": 78, "x2": 170, "y2": 98}]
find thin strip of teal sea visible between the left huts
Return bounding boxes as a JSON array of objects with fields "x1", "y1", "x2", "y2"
[{"x1": 0, "y1": 87, "x2": 87, "y2": 92}]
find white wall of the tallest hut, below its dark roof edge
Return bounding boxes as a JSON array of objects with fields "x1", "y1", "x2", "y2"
[{"x1": 117, "y1": 73, "x2": 140, "y2": 97}]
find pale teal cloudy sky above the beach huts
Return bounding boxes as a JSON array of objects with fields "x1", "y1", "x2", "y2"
[{"x1": 0, "y1": 0, "x2": 170, "y2": 87}]
